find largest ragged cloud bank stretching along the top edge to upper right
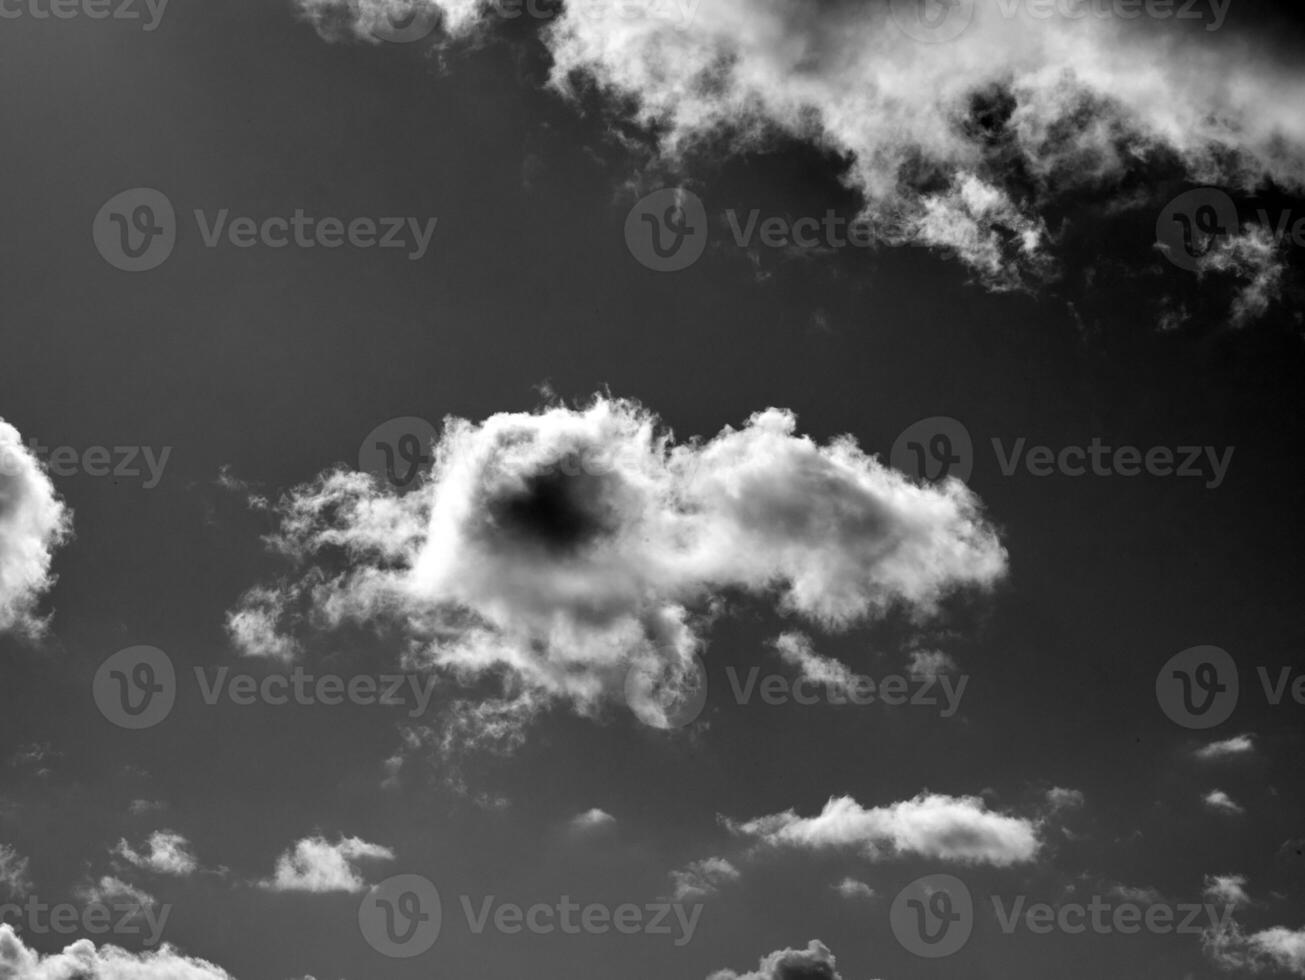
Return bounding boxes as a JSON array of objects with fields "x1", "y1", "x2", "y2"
[{"x1": 299, "y1": 0, "x2": 1305, "y2": 289}]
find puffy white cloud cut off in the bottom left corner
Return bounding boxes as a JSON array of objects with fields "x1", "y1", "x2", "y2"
[{"x1": 0, "y1": 923, "x2": 232, "y2": 980}]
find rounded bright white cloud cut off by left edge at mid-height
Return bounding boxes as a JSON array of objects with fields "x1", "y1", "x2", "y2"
[{"x1": 0, "y1": 419, "x2": 72, "y2": 635}]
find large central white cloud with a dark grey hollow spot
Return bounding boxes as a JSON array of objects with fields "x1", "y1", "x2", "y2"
[{"x1": 232, "y1": 397, "x2": 1006, "y2": 735}]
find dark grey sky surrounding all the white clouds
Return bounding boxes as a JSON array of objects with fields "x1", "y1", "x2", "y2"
[{"x1": 0, "y1": 0, "x2": 1305, "y2": 980}]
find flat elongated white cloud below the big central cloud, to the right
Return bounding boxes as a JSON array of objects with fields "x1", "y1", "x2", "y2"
[{"x1": 726, "y1": 793, "x2": 1040, "y2": 866}]
